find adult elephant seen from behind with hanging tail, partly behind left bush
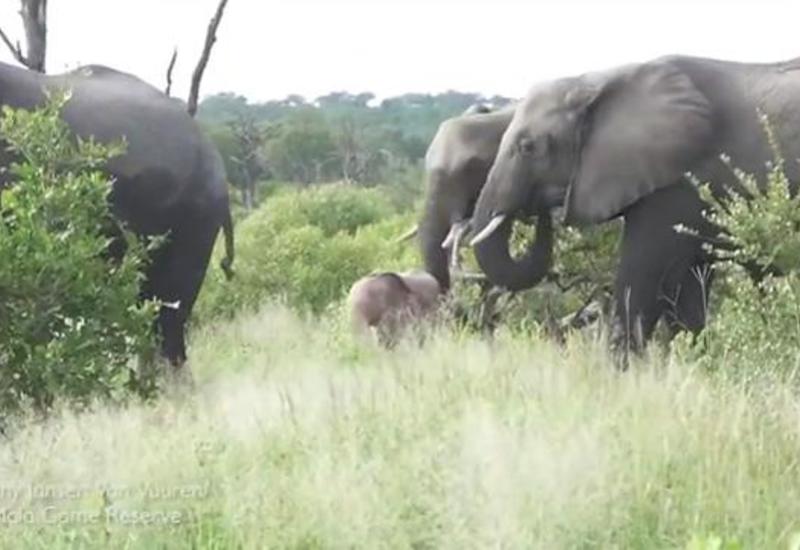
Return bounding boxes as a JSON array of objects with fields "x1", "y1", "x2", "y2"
[{"x1": 0, "y1": 63, "x2": 233, "y2": 367}]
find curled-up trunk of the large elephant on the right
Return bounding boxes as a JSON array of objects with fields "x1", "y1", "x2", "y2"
[{"x1": 475, "y1": 210, "x2": 553, "y2": 291}]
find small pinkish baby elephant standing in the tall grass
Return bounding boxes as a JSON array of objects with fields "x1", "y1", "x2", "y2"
[{"x1": 347, "y1": 272, "x2": 440, "y2": 347}]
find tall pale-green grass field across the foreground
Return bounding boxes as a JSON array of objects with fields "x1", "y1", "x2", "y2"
[{"x1": 0, "y1": 306, "x2": 800, "y2": 550}]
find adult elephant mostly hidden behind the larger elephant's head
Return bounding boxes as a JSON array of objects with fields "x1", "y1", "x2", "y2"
[{"x1": 419, "y1": 105, "x2": 552, "y2": 292}]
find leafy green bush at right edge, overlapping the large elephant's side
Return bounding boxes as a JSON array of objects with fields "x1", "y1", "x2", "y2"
[{"x1": 678, "y1": 121, "x2": 800, "y2": 377}]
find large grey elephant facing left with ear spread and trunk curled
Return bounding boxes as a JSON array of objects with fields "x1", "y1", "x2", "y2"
[{"x1": 472, "y1": 56, "x2": 800, "y2": 349}]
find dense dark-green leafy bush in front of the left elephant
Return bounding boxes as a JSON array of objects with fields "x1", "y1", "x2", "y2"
[{"x1": 0, "y1": 92, "x2": 154, "y2": 413}]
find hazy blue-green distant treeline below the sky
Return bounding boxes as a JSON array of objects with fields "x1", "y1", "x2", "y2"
[{"x1": 198, "y1": 91, "x2": 512, "y2": 207}]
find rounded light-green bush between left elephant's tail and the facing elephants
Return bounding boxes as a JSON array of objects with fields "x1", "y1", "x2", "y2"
[{"x1": 196, "y1": 183, "x2": 419, "y2": 321}]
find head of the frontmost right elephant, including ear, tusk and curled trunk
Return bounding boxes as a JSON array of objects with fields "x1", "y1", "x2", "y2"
[{"x1": 472, "y1": 59, "x2": 712, "y2": 290}]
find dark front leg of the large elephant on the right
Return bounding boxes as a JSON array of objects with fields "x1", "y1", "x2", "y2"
[{"x1": 612, "y1": 185, "x2": 707, "y2": 358}]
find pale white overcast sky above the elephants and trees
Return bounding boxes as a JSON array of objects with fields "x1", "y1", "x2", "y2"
[{"x1": 0, "y1": 0, "x2": 800, "y2": 101}]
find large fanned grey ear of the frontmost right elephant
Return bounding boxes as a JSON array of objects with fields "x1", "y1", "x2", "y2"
[{"x1": 566, "y1": 62, "x2": 712, "y2": 225}]
